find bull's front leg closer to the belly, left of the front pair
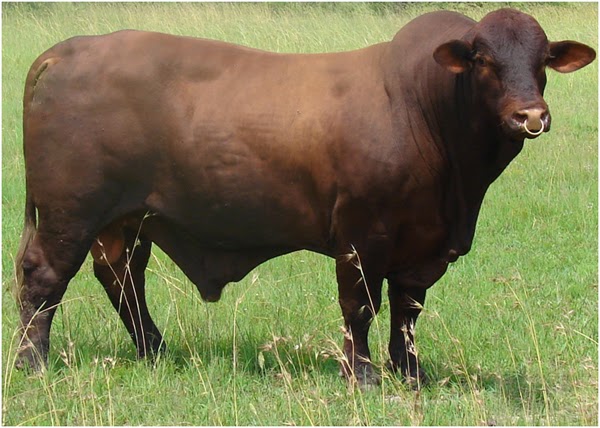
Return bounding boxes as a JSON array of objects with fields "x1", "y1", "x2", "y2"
[{"x1": 336, "y1": 250, "x2": 383, "y2": 387}]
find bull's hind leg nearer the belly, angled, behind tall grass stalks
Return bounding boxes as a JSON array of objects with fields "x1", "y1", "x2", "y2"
[{"x1": 94, "y1": 229, "x2": 165, "y2": 358}]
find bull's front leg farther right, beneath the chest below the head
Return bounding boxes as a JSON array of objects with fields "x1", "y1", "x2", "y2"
[{"x1": 388, "y1": 280, "x2": 427, "y2": 389}]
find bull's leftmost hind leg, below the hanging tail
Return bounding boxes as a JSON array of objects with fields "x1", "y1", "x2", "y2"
[{"x1": 16, "y1": 229, "x2": 89, "y2": 370}]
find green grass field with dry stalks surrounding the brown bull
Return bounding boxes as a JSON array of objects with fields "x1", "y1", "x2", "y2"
[{"x1": 2, "y1": 3, "x2": 598, "y2": 426}]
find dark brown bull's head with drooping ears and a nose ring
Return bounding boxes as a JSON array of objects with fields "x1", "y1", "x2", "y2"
[{"x1": 433, "y1": 9, "x2": 596, "y2": 140}]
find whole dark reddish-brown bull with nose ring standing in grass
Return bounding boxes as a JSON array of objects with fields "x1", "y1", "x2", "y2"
[{"x1": 17, "y1": 9, "x2": 596, "y2": 383}]
